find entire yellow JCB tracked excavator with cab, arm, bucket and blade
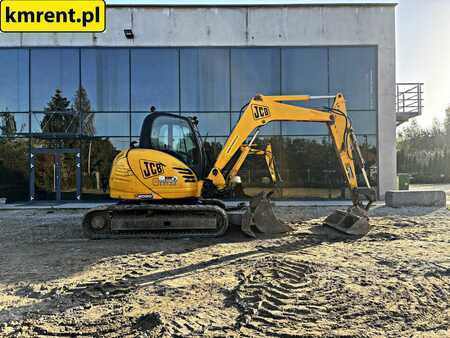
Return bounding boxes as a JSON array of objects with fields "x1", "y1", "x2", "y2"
[{"x1": 83, "y1": 94, "x2": 375, "y2": 239}]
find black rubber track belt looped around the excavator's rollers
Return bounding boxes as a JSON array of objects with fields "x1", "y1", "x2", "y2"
[{"x1": 83, "y1": 204, "x2": 228, "y2": 239}]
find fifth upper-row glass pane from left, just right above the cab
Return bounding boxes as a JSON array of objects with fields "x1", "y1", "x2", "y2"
[{"x1": 180, "y1": 48, "x2": 230, "y2": 111}]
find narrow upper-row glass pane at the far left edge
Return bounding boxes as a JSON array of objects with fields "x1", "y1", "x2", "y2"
[{"x1": 0, "y1": 49, "x2": 29, "y2": 112}]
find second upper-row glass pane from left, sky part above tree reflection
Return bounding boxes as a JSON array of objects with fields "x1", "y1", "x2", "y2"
[{"x1": 30, "y1": 48, "x2": 80, "y2": 111}]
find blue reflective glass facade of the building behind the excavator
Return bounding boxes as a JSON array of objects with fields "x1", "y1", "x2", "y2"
[{"x1": 0, "y1": 47, "x2": 378, "y2": 200}]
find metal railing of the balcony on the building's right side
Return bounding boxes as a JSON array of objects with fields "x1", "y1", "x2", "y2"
[{"x1": 396, "y1": 83, "x2": 423, "y2": 124}]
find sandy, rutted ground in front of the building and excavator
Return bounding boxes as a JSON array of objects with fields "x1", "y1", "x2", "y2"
[{"x1": 0, "y1": 207, "x2": 450, "y2": 337}]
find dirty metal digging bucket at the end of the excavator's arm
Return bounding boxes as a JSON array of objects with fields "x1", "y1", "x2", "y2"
[{"x1": 324, "y1": 207, "x2": 371, "y2": 236}]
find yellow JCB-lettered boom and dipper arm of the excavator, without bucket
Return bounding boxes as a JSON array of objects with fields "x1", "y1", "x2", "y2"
[{"x1": 207, "y1": 94, "x2": 375, "y2": 208}]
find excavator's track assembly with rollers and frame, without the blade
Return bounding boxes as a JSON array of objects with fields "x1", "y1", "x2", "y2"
[{"x1": 83, "y1": 203, "x2": 229, "y2": 239}]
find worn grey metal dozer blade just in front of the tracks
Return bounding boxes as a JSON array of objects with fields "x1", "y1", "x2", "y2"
[{"x1": 250, "y1": 191, "x2": 292, "y2": 234}]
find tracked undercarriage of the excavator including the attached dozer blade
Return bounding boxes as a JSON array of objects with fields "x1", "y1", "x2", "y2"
[{"x1": 83, "y1": 193, "x2": 292, "y2": 239}]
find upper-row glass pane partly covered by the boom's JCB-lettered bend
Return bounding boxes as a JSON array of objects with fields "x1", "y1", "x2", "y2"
[{"x1": 231, "y1": 48, "x2": 281, "y2": 111}]
